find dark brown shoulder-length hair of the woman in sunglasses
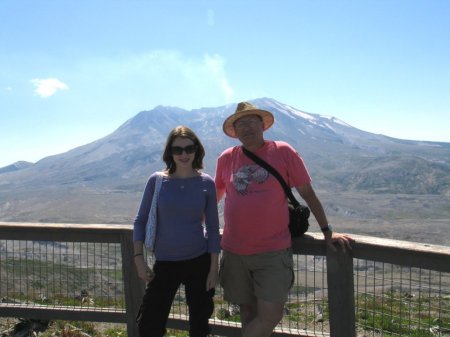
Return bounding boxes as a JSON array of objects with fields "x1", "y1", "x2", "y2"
[{"x1": 163, "y1": 125, "x2": 205, "y2": 174}]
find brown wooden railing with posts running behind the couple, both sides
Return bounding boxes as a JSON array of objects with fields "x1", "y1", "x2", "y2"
[{"x1": 0, "y1": 222, "x2": 450, "y2": 337}]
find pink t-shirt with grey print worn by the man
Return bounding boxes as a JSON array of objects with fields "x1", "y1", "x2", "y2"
[{"x1": 215, "y1": 141, "x2": 311, "y2": 255}]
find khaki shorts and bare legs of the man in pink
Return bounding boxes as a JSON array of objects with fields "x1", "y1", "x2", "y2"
[{"x1": 221, "y1": 249, "x2": 294, "y2": 337}]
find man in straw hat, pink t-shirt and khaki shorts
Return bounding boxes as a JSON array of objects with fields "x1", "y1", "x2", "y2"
[{"x1": 215, "y1": 102, "x2": 353, "y2": 337}]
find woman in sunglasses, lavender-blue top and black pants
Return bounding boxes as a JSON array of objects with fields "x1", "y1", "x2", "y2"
[{"x1": 134, "y1": 126, "x2": 220, "y2": 337}]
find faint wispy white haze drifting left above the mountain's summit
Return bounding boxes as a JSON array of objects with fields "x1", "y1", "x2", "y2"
[{"x1": 78, "y1": 50, "x2": 234, "y2": 108}]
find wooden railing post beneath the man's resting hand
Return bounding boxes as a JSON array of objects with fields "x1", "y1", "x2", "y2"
[{"x1": 327, "y1": 247, "x2": 356, "y2": 337}]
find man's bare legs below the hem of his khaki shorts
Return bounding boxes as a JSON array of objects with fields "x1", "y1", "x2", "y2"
[{"x1": 240, "y1": 300, "x2": 284, "y2": 337}]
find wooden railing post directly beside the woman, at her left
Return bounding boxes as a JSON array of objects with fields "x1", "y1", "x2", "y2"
[{"x1": 121, "y1": 231, "x2": 144, "y2": 337}]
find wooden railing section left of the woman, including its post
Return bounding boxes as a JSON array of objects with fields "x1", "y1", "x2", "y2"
[{"x1": 0, "y1": 222, "x2": 143, "y2": 336}]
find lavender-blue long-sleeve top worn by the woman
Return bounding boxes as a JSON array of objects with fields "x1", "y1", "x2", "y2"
[{"x1": 133, "y1": 173, "x2": 220, "y2": 261}]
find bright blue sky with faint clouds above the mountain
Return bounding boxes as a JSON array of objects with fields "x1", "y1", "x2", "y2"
[{"x1": 0, "y1": 0, "x2": 450, "y2": 167}]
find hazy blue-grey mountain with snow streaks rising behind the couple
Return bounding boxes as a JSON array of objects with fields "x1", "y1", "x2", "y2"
[{"x1": 0, "y1": 98, "x2": 450, "y2": 244}]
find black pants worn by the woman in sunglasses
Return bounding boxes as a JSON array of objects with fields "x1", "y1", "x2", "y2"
[{"x1": 137, "y1": 254, "x2": 214, "y2": 337}]
